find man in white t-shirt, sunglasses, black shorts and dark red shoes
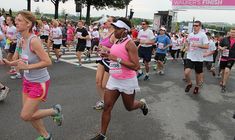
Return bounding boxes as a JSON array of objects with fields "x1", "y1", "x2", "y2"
[{"x1": 184, "y1": 21, "x2": 209, "y2": 94}]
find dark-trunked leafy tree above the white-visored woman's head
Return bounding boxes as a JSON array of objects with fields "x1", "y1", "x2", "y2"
[{"x1": 77, "y1": 0, "x2": 131, "y2": 24}]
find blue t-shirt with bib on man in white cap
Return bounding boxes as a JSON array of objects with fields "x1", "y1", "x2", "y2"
[{"x1": 155, "y1": 35, "x2": 171, "y2": 54}]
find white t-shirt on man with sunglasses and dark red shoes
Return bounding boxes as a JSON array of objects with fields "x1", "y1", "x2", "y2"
[{"x1": 187, "y1": 32, "x2": 209, "y2": 62}]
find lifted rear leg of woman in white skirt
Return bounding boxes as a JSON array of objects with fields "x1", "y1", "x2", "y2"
[{"x1": 121, "y1": 93, "x2": 142, "y2": 111}]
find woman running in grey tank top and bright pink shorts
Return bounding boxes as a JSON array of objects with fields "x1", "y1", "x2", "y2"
[{"x1": 4, "y1": 11, "x2": 62, "y2": 140}]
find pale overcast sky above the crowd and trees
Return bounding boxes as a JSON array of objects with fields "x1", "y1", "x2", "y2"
[{"x1": 0, "y1": 0, "x2": 235, "y2": 23}]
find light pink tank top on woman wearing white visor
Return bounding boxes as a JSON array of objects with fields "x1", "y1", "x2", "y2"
[{"x1": 109, "y1": 38, "x2": 136, "y2": 80}]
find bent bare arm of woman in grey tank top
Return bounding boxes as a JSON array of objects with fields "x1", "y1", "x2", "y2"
[{"x1": 17, "y1": 38, "x2": 51, "y2": 70}]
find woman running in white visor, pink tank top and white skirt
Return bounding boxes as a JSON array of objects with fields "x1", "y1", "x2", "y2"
[{"x1": 91, "y1": 18, "x2": 148, "y2": 140}]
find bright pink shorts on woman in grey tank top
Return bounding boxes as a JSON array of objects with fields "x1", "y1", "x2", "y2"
[{"x1": 23, "y1": 78, "x2": 50, "y2": 101}]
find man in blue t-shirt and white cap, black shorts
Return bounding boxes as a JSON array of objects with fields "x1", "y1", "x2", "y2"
[{"x1": 154, "y1": 27, "x2": 171, "y2": 75}]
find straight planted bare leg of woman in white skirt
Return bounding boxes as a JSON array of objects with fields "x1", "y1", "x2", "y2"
[{"x1": 101, "y1": 90, "x2": 120, "y2": 135}]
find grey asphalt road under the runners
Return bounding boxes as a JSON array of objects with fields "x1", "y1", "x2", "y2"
[{"x1": 0, "y1": 55, "x2": 235, "y2": 140}]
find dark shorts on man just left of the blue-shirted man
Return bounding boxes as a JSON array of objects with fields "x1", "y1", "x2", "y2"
[{"x1": 138, "y1": 46, "x2": 153, "y2": 62}]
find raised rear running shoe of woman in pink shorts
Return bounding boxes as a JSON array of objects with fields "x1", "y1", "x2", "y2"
[{"x1": 52, "y1": 104, "x2": 63, "y2": 126}]
